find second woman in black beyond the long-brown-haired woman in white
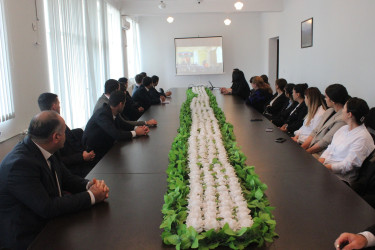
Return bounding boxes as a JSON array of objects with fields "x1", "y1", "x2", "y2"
[{"x1": 269, "y1": 83, "x2": 298, "y2": 127}]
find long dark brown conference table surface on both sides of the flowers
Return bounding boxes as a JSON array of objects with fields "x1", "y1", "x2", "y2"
[{"x1": 30, "y1": 88, "x2": 375, "y2": 249}]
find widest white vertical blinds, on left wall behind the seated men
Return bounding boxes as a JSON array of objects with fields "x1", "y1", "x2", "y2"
[{"x1": 44, "y1": 0, "x2": 123, "y2": 127}]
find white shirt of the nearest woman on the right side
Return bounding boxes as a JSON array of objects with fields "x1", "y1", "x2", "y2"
[{"x1": 321, "y1": 124, "x2": 375, "y2": 183}]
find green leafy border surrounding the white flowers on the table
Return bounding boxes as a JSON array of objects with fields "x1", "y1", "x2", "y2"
[{"x1": 160, "y1": 89, "x2": 277, "y2": 249}]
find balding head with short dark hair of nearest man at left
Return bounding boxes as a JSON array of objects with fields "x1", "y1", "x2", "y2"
[{"x1": 28, "y1": 110, "x2": 62, "y2": 141}]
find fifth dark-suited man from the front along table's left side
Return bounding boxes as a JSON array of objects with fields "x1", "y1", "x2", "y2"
[{"x1": 118, "y1": 77, "x2": 145, "y2": 121}]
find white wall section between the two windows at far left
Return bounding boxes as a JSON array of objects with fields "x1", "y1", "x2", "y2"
[{"x1": 0, "y1": 0, "x2": 49, "y2": 141}]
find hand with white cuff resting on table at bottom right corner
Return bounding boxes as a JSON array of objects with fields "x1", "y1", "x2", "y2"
[{"x1": 335, "y1": 225, "x2": 375, "y2": 250}]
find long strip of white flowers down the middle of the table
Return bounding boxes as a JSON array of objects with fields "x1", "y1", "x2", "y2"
[{"x1": 186, "y1": 87, "x2": 253, "y2": 232}]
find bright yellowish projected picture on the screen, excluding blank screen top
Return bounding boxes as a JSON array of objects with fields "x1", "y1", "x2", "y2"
[{"x1": 176, "y1": 47, "x2": 223, "y2": 75}]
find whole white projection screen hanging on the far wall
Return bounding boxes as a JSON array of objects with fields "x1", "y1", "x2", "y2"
[{"x1": 174, "y1": 36, "x2": 224, "y2": 75}]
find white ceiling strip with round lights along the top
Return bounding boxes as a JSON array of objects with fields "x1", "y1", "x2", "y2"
[{"x1": 117, "y1": 0, "x2": 283, "y2": 16}]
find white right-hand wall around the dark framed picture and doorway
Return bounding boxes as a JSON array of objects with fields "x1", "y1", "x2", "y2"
[{"x1": 261, "y1": 0, "x2": 375, "y2": 107}]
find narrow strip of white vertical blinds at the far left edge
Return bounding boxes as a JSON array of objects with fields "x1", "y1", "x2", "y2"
[{"x1": 0, "y1": 0, "x2": 14, "y2": 122}]
